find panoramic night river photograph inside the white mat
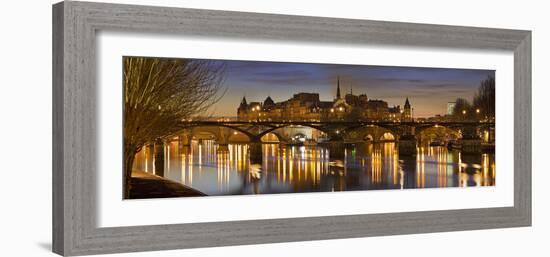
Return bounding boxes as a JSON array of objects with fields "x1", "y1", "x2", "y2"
[{"x1": 122, "y1": 56, "x2": 496, "y2": 199}]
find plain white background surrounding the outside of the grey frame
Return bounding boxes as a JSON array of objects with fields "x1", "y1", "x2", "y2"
[{"x1": 0, "y1": 0, "x2": 550, "y2": 257}]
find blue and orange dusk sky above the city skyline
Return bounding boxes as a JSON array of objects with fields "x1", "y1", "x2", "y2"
[{"x1": 205, "y1": 58, "x2": 495, "y2": 117}]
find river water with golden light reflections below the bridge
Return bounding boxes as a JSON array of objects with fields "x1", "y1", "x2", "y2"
[{"x1": 134, "y1": 141, "x2": 495, "y2": 195}]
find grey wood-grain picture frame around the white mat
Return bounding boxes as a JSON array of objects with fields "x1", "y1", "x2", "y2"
[{"x1": 53, "y1": 1, "x2": 531, "y2": 255}]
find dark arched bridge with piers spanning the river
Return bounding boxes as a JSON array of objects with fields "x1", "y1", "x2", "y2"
[{"x1": 143, "y1": 121, "x2": 495, "y2": 167}]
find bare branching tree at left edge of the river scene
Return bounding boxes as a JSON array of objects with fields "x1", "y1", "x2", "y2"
[{"x1": 123, "y1": 57, "x2": 224, "y2": 198}]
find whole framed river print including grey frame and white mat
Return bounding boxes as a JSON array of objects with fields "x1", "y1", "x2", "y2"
[{"x1": 53, "y1": 1, "x2": 531, "y2": 255}]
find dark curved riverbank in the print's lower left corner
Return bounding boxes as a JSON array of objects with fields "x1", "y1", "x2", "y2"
[{"x1": 130, "y1": 170, "x2": 206, "y2": 199}]
